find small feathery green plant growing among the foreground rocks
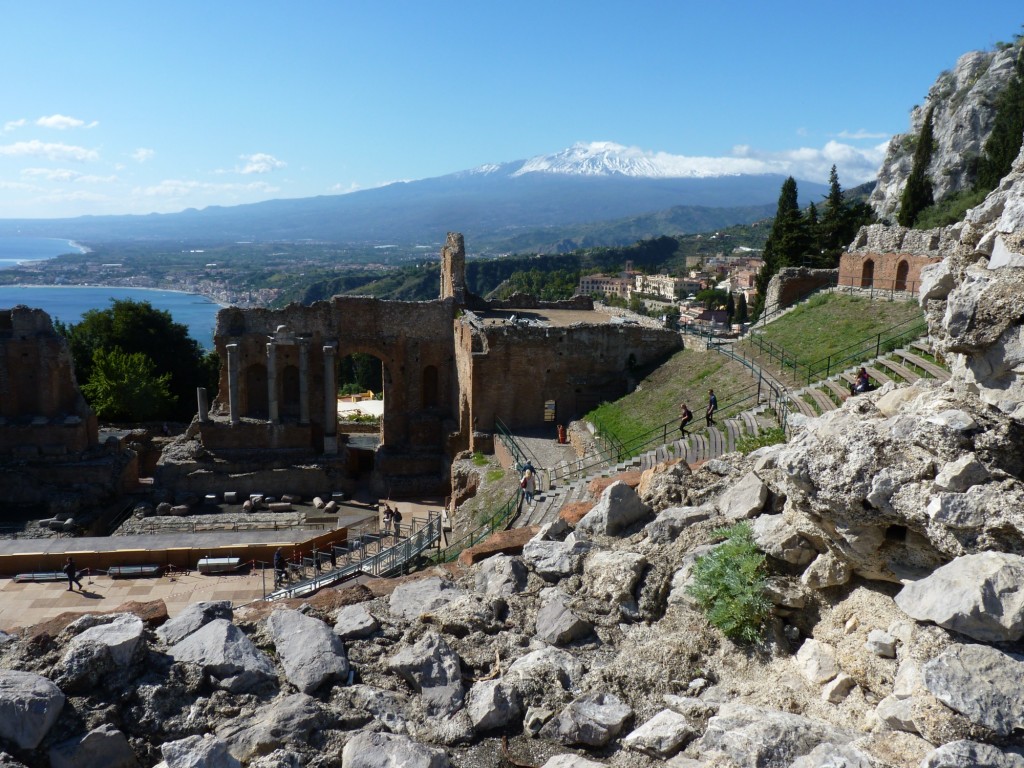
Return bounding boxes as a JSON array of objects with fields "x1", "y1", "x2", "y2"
[{"x1": 686, "y1": 522, "x2": 771, "y2": 643}]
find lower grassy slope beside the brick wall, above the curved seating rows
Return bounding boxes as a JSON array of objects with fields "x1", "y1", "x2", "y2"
[{"x1": 587, "y1": 349, "x2": 755, "y2": 441}]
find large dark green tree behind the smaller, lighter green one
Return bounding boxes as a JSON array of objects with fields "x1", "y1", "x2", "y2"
[{"x1": 55, "y1": 299, "x2": 219, "y2": 420}]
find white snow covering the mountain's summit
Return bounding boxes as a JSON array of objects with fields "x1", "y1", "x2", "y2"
[{"x1": 512, "y1": 141, "x2": 766, "y2": 178}]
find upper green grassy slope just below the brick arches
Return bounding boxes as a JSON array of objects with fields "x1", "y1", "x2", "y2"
[{"x1": 737, "y1": 294, "x2": 925, "y2": 365}]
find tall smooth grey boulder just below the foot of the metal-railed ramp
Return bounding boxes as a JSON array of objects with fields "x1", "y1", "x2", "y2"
[{"x1": 266, "y1": 609, "x2": 348, "y2": 693}]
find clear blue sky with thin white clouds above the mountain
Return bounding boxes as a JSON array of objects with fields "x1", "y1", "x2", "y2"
[{"x1": 0, "y1": 0, "x2": 1024, "y2": 218}]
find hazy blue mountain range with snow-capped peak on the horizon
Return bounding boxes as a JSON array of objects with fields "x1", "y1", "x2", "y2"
[{"x1": 0, "y1": 142, "x2": 827, "y2": 252}]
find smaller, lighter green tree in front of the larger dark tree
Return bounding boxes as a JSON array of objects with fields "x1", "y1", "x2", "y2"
[{"x1": 82, "y1": 347, "x2": 174, "y2": 422}]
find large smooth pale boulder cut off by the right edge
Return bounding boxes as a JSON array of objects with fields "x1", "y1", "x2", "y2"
[{"x1": 896, "y1": 552, "x2": 1024, "y2": 642}]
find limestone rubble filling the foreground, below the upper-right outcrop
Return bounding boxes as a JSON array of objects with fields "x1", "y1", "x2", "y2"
[{"x1": 0, "y1": 368, "x2": 1024, "y2": 768}]
